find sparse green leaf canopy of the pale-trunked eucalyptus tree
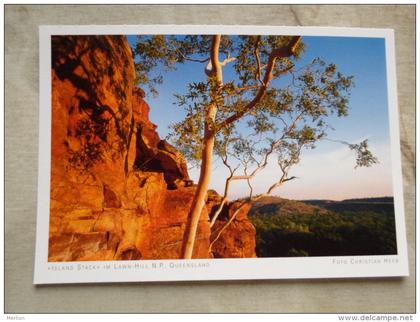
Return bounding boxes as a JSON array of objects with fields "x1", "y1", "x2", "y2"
[{"x1": 135, "y1": 35, "x2": 377, "y2": 172}]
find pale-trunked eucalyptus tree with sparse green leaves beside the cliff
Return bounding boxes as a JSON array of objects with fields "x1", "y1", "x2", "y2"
[{"x1": 135, "y1": 35, "x2": 377, "y2": 259}]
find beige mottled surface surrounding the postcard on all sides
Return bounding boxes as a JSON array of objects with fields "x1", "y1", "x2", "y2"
[{"x1": 5, "y1": 5, "x2": 415, "y2": 313}]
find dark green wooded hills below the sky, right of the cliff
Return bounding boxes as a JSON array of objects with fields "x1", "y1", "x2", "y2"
[{"x1": 250, "y1": 197, "x2": 397, "y2": 257}]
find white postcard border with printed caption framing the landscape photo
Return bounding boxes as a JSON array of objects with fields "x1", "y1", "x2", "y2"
[{"x1": 34, "y1": 25, "x2": 409, "y2": 284}]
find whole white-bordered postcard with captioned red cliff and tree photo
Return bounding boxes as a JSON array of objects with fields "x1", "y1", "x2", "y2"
[{"x1": 34, "y1": 25, "x2": 409, "y2": 284}]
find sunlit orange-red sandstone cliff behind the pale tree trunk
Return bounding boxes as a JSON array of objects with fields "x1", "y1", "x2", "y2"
[{"x1": 49, "y1": 36, "x2": 255, "y2": 261}]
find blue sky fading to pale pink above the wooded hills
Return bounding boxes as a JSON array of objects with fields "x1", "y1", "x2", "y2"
[{"x1": 128, "y1": 36, "x2": 392, "y2": 200}]
